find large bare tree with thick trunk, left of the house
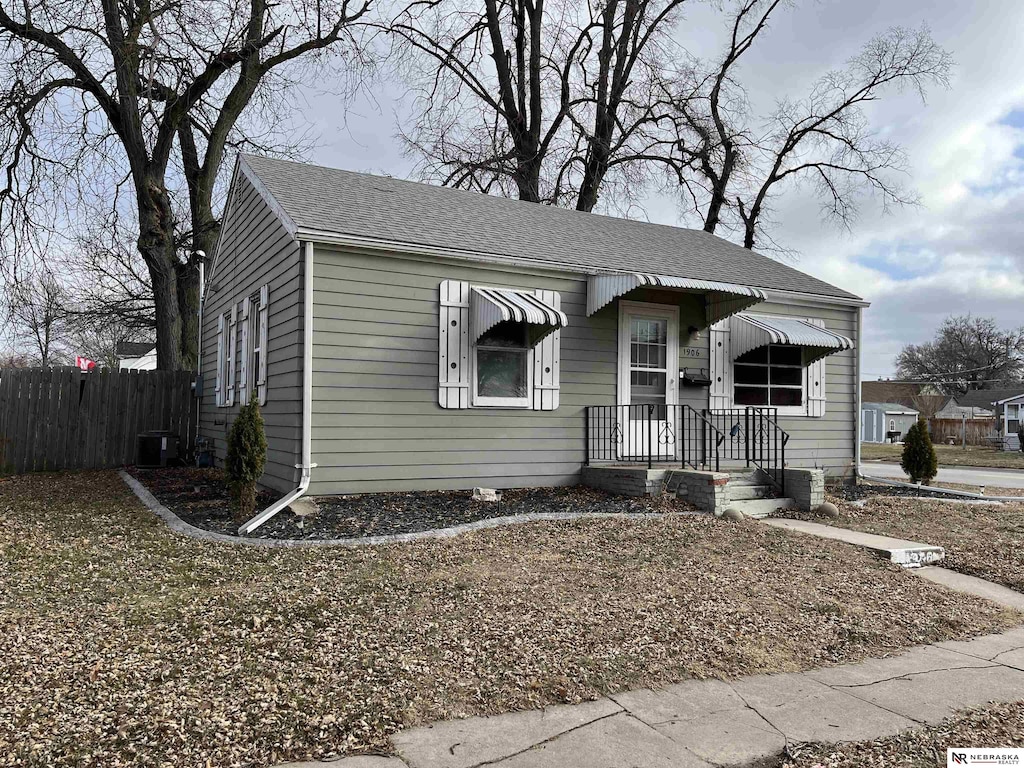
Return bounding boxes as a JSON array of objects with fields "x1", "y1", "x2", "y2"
[{"x1": 0, "y1": 0, "x2": 370, "y2": 369}]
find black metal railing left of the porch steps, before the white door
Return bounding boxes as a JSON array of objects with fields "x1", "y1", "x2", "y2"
[{"x1": 584, "y1": 403, "x2": 725, "y2": 471}]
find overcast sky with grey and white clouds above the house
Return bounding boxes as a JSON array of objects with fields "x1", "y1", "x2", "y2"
[{"x1": 292, "y1": 0, "x2": 1024, "y2": 379}]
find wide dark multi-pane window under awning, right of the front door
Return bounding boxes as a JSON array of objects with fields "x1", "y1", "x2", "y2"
[{"x1": 732, "y1": 344, "x2": 806, "y2": 409}]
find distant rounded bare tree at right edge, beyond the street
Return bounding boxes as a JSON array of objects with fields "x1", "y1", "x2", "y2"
[{"x1": 896, "y1": 314, "x2": 1024, "y2": 395}]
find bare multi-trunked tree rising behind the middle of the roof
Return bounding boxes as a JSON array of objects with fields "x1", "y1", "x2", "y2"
[{"x1": 390, "y1": 0, "x2": 696, "y2": 211}]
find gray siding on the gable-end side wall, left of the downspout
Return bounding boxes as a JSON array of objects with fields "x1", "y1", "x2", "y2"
[{"x1": 200, "y1": 174, "x2": 302, "y2": 492}]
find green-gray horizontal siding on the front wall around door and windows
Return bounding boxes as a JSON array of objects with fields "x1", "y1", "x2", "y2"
[{"x1": 310, "y1": 246, "x2": 857, "y2": 495}]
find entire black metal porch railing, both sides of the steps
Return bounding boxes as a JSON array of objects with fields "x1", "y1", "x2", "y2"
[{"x1": 584, "y1": 403, "x2": 790, "y2": 494}]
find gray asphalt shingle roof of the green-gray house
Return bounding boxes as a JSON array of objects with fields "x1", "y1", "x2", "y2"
[{"x1": 244, "y1": 155, "x2": 859, "y2": 299}]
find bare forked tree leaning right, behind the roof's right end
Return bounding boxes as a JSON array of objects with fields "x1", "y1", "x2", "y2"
[{"x1": 679, "y1": 12, "x2": 952, "y2": 248}]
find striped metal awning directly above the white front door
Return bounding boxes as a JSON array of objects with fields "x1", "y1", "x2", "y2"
[{"x1": 587, "y1": 272, "x2": 768, "y2": 327}]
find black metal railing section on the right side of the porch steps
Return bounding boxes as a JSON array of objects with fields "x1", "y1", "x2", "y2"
[{"x1": 705, "y1": 406, "x2": 790, "y2": 495}]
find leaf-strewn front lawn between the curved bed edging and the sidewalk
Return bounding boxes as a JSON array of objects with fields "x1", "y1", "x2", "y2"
[{"x1": 0, "y1": 472, "x2": 1020, "y2": 768}]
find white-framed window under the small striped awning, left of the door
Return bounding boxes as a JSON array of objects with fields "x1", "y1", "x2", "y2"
[{"x1": 473, "y1": 322, "x2": 534, "y2": 408}]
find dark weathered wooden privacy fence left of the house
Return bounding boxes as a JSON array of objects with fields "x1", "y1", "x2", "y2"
[{"x1": 0, "y1": 368, "x2": 197, "y2": 473}]
